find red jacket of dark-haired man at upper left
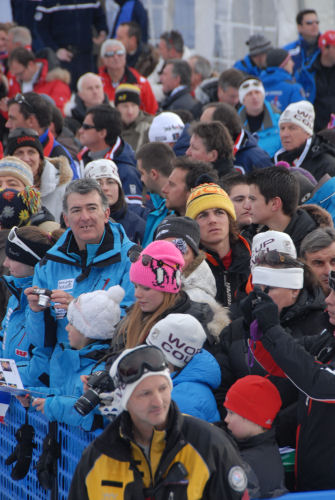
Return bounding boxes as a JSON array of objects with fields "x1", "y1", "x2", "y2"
[{"x1": 7, "y1": 59, "x2": 71, "y2": 113}]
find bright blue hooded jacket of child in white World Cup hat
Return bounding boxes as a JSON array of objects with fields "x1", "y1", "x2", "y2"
[{"x1": 171, "y1": 349, "x2": 221, "y2": 422}]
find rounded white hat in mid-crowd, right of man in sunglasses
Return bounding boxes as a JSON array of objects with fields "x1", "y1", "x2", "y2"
[{"x1": 149, "y1": 111, "x2": 184, "y2": 142}]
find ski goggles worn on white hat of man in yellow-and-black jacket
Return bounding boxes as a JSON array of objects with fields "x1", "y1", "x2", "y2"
[{"x1": 117, "y1": 346, "x2": 168, "y2": 384}]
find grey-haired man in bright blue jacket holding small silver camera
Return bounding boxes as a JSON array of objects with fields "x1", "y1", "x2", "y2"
[{"x1": 25, "y1": 179, "x2": 134, "y2": 385}]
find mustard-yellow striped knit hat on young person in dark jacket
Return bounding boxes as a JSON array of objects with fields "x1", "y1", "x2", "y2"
[{"x1": 185, "y1": 183, "x2": 236, "y2": 220}]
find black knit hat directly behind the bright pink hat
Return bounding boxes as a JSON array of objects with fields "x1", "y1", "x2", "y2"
[{"x1": 155, "y1": 215, "x2": 200, "y2": 255}]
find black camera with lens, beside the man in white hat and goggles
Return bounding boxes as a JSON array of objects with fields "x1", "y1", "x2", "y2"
[{"x1": 74, "y1": 371, "x2": 115, "y2": 417}]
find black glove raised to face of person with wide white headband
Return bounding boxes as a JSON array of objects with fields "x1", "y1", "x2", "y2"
[{"x1": 249, "y1": 287, "x2": 279, "y2": 333}]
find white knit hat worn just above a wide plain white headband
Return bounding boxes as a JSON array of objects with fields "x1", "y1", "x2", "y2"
[{"x1": 250, "y1": 231, "x2": 297, "y2": 269}]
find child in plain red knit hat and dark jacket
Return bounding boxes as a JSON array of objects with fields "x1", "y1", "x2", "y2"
[{"x1": 224, "y1": 375, "x2": 287, "y2": 498}]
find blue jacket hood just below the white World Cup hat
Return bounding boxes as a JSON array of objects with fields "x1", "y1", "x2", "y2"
[{"x1": 171, "y1": 349, "x2": 221, "y2": 389}]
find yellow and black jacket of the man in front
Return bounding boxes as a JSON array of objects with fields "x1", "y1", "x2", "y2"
[{"x1": 68, "y1": 402, "x2": 248, "y2": 500}]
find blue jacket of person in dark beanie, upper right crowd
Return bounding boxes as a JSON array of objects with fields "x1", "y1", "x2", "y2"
[{"x1": 260, "y1": 66, "x2": 305, "y2": 112}]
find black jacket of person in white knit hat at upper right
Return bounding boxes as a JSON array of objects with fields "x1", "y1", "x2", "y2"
[{"x1": 274, "y1": 135, "x2": 335, "y2": 181}]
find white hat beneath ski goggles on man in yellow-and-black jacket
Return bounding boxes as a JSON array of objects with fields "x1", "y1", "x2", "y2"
[{"x1": 109, "y1": 345, "x2": 173, "y2": 410}]
